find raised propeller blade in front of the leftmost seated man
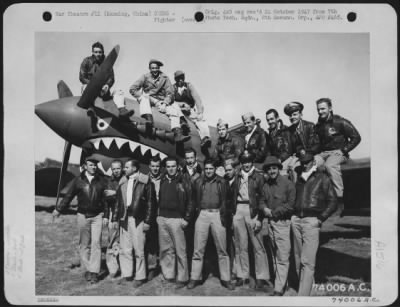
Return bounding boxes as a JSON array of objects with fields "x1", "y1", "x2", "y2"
[{"x1": 78, "y1": 45, "x2": 119, "y2": 109}]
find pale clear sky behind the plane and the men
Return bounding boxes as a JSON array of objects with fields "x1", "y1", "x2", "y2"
[{"x1": 35, "y1": 32, "x2": 371, "y2": 163}]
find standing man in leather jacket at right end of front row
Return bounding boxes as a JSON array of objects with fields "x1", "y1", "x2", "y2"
[{"x1": 291, "y1": 153, "x2": 337, "y2": 296}]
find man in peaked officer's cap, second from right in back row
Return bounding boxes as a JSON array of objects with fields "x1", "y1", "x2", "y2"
[{"x1": 283, "y1": 101, "x2": 319, "y2": 157}]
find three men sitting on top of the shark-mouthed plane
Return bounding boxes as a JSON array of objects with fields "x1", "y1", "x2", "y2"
[{"x1": 79, "y1": 42, "x2": 211, "y2": 148}]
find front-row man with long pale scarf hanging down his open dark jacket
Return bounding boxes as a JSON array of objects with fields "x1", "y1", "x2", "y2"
[{"x1": 112, "y1": 160, "x2": 156, "y2": 288}]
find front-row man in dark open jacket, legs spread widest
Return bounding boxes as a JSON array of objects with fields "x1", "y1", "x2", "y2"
[{"x1": 188, "y1": 159, "x2": 235, "y2": 290}]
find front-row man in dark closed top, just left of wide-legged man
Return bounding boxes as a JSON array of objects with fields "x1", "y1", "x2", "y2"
[{"x1": 157, "y1": 158, "x2": 193, "y2": 289}]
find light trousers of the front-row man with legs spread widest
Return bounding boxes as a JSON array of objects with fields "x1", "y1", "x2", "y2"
[{"x1": 190, "y1": 210, "x2": 231, "y2": 281}]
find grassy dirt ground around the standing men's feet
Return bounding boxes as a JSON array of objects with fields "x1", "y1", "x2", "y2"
[{"x1": 35, "y1": 197, "x2": 371, "y2": 296}]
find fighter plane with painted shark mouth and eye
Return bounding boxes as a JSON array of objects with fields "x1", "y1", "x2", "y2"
[{"x1": 35, "y1": 45, "x2": 370, "y2": 217}]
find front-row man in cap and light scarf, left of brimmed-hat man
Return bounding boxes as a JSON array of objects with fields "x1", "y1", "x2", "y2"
[{"x1": 231, "y1": 150, "x2": 270, "y2": 289}]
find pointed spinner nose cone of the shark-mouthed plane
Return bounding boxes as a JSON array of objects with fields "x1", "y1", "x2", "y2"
[{"x1": 35, "y1": 97, "x2": 87, "y2": 145}]
